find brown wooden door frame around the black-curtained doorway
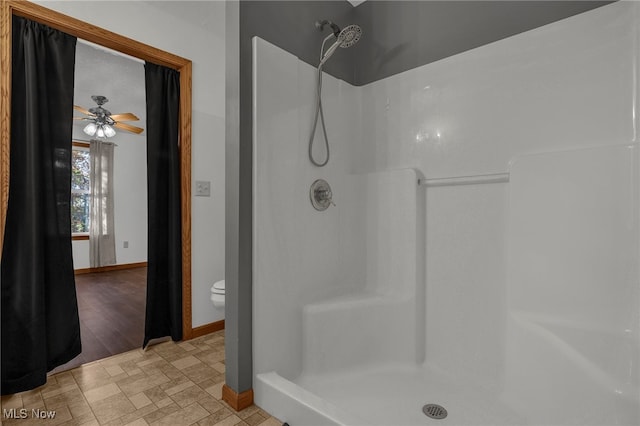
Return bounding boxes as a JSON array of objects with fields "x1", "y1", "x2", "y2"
[{"x1": 0, "y1": 0, "x2": 193, "y2": 340}]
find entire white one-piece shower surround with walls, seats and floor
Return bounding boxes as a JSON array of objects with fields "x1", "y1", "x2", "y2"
[{"x1": 253, "y1": 2, "x2": 640, "y2": 425}]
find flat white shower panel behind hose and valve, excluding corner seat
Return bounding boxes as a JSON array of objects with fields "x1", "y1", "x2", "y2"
[{"x1": 253, "y1": 38, "x2": 366, "y2": 379}]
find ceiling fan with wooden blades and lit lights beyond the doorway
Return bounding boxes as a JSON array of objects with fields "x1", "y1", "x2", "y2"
[{"x1": 73, "y1": 95, "x2": 144, "y2": 138}]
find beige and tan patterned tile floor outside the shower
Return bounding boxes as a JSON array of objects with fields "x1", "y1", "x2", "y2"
[{"x1": 0, "y1": 330, "x2": 282, "y2": 426}]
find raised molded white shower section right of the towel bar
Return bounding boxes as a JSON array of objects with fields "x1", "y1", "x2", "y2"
[{"x1": 504, "y1": 144, "x2": 640, "y2": 424}]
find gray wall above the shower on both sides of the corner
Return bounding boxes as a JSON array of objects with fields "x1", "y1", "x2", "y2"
[{"x1": 240, "y1": 0, "x2": 612, "y2": 86}]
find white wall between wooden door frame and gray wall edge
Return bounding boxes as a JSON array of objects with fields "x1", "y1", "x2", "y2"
[{"x1": 37, "y1": 1, "x2": 225, "y2": 327}]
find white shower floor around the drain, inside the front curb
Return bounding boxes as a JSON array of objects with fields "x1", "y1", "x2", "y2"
[{"x1": 297, "y1": 365, "x2": 525, "y2": 425}]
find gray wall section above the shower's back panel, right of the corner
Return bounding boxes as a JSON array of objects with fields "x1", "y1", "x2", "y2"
[{"x1": 353, "y1": 1, "x2": 612, "y2": 86}]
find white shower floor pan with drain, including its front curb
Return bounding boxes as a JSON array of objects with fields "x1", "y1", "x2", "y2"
[{"x1": 256, "y1": 365, "x2": 527, "y2": 426}]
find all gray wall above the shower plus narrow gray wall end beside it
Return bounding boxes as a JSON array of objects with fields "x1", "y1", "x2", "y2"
[{"x1": 225, "y1": 0, "x2": 610, "y2": 393}]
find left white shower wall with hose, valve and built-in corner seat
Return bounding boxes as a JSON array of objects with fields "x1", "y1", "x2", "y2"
[{"x1": 253, "y1": 38, "x2": 424, "y2": 380}]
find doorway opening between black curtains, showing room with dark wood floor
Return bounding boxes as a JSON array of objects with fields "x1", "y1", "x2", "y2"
[{"x1": 50, "y1": 39, "x2": 148, "y2": 374}]
